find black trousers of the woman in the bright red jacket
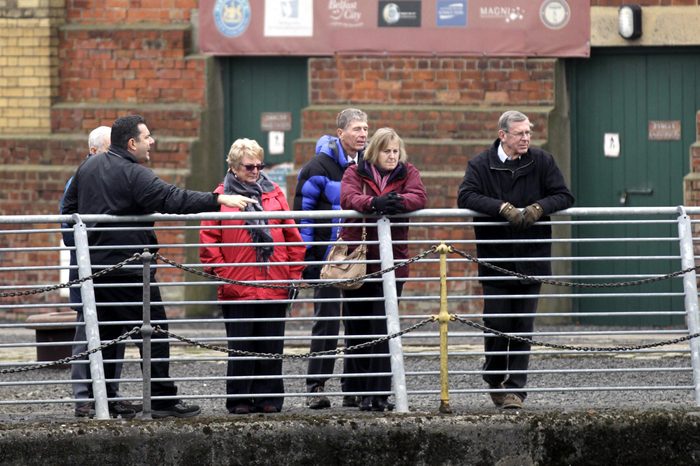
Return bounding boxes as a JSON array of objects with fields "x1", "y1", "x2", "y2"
[{"x1": 221, "y1": 301, "x2": 287, "y2": 411}]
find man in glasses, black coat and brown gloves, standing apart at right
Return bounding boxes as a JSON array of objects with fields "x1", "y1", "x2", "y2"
[{"x1": 457, "y1": 110, "x2": 574, "y2": 409}]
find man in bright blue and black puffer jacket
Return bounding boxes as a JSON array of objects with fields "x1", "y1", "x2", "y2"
[{"x1": 294, "y1": 108, "x2": 369, "y2": 409}]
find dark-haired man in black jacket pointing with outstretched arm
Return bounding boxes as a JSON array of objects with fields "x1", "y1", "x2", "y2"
[{"x1": 61, "y1": 115, "x2": 255, "y2": 418}]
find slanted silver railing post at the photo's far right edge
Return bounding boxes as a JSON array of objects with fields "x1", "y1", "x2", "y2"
[{"x1": 678, "y1": 206, "x2": 700, "y2": 406}]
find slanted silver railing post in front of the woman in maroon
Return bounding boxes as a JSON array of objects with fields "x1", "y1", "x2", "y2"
[{"x1": 377, "y1": 217, "x2": 408, "y2": 413}]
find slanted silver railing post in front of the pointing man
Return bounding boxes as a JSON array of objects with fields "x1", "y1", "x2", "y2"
[{"x1": 73, "y1": 214, "x2": 109, "y2": 419}]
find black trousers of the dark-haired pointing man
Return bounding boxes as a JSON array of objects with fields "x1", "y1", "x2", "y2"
[{"x1": 89, "y1": 277, "x2": 178, "y2": 409}]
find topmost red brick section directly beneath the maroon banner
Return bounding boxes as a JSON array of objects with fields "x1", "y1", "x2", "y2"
[{"x1": 309, "y1": 56, "x2": 554, "y2": 106}]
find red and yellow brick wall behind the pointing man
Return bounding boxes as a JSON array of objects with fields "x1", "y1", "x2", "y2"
[{"x1": 0, "y1": 0, "x2": 205, "y2": 312}]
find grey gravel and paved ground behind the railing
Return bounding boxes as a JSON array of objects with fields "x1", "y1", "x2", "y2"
[{"x1": 0, "y1": 322, "x2": 696, "y2": 422}]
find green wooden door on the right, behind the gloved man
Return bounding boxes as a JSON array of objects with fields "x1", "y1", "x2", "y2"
[{"x1": 567, "y1": 49, "x2": 700, "y2": 325}]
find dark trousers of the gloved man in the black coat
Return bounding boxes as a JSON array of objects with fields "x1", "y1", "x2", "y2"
[{"x1": 483, "y1": 284, "x2": 541, "y2": 399}]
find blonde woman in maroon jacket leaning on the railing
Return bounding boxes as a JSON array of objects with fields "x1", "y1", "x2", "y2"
[{"x1": 340, "y1": 128, "x2": 428, "y2": 411}]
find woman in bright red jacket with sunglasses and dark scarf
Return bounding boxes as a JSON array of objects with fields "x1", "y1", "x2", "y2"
[{"x1": 199, "y1": 139, "x2": 306, "y2": 414}]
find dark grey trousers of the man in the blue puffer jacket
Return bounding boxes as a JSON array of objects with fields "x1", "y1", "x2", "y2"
[{"x1": 306, "y1": 286, "x2": 345, "y2": 392}]
